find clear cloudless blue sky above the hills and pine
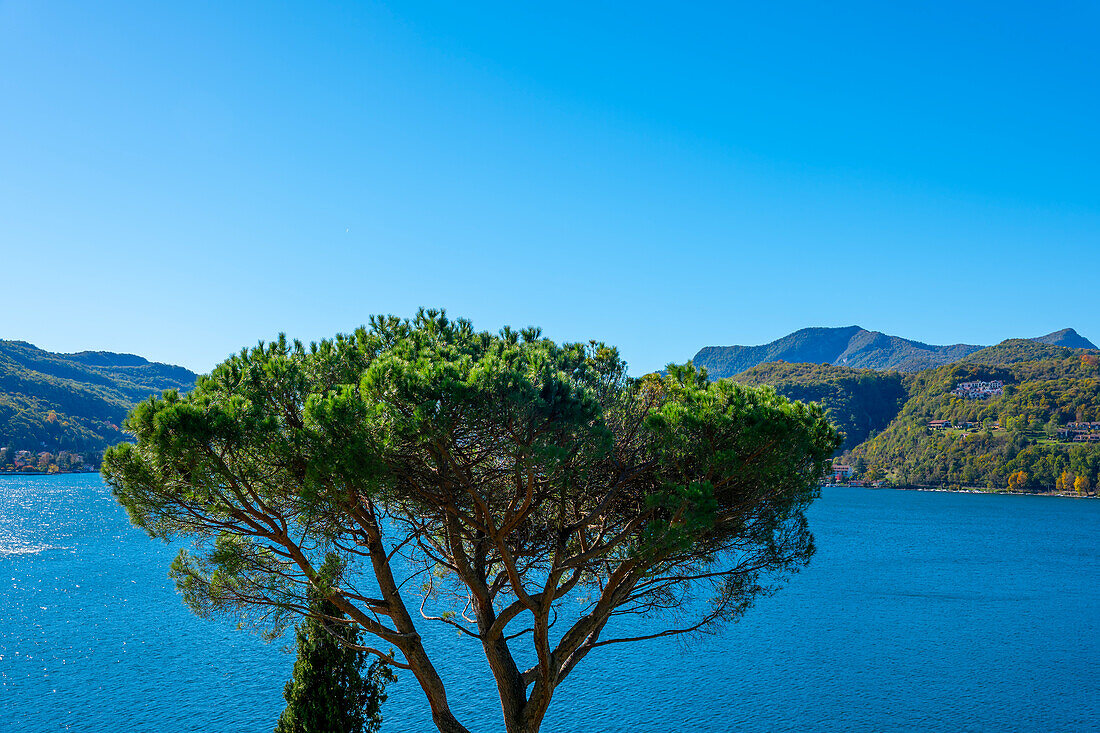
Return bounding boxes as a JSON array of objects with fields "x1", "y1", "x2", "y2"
[{"x1": 0, "y1": 0, "x2": 1100, "y2": 373}]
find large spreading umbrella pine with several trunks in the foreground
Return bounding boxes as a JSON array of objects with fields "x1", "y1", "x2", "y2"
[{"x1": 103, "y1": 311, "x2": 839, "y2": 733}]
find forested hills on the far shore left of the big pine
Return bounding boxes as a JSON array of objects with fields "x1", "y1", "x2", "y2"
[{"x1": 0, "y1": 340, "x2": 197, "y2": 461}]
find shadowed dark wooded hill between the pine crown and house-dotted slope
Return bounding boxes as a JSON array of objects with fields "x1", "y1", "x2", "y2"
[{"x1": 734, "y1": 362, "x2": 906, "y2": 449}]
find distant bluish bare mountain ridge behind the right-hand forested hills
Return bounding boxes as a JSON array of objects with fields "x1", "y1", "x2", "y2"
[{"x1": 692, "y1": 326, "x2": 1096, "y2": 379}]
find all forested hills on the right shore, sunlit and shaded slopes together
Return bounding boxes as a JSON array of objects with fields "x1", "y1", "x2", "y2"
[{"x1": 708, "y1": 330, "x2": 1100, "y2": 493}]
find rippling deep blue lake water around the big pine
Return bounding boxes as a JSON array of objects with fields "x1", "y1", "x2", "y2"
[{"x1": 0, "y1": 474, "x2": 1100, "y2": 733}]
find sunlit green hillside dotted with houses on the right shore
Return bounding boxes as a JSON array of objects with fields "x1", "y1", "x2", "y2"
[{"x1": 847, "y1": 341, "x2": 1100, "y2": 491}]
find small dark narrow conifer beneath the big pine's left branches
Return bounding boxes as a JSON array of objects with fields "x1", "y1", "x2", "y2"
[{"x1": 275, "y1": 562, "x2": 397, "y2": 733}]
